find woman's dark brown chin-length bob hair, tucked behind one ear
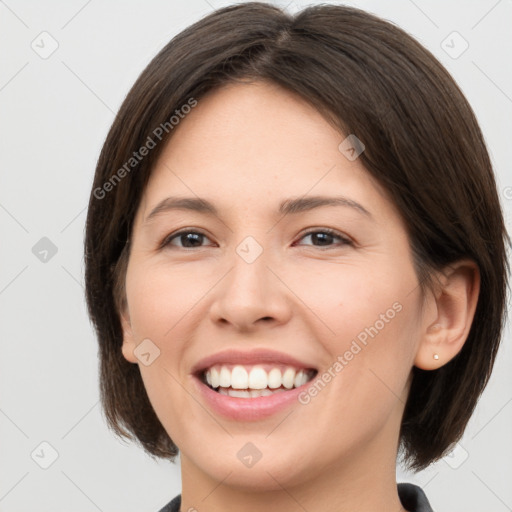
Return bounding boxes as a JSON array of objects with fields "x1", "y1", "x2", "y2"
[{"x1": 84, "y1": 2, "x2": 510, "y2": 471}]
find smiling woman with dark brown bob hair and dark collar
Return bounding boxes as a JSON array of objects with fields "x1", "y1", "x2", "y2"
[{"x1": 85, "y1": 3, "x2": 508, "y2": 512}]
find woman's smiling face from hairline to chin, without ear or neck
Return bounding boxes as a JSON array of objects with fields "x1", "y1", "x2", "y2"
[{"x1": 123, "y1": 83, "x2": 428, "y2": 489}]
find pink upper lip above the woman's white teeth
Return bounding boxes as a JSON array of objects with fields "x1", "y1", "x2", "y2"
[{"x1": 192, "y1": 348, "x2": 316, "y2": 374}]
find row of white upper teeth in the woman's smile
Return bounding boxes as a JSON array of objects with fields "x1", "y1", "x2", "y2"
[{"x1": 205, "y1": 365, "x2": 312, "y2": 389}]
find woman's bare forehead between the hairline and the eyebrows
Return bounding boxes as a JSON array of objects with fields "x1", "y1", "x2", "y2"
[{"x1": 136, "y1": 82, "x2": 391, "y2": 228}]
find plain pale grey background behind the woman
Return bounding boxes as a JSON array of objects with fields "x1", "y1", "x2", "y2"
[{"x1": 0, "y1": 0, "x2": 512, "y2": 512}]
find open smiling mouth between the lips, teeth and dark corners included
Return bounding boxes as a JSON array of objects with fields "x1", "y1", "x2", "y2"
[{"x1": 199, "y1": 365, "x2": 318, "y2": 398}]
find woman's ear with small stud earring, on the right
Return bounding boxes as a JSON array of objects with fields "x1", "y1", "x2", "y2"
[{"x1": 414, "y1": 260, "x2": 480, "y2": 370}]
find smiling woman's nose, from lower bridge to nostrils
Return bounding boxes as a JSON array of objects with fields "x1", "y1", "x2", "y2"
[{"x1": 210, "y1": 240, "x2": 292, "y2": 332}]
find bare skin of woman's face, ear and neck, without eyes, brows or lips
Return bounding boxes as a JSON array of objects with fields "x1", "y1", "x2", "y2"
[{"x1": 122, "y1": 82, "x2": 479, "y2": 512}]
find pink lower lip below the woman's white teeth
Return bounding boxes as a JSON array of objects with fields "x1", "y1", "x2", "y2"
[{"x1": 194, "y1": 376, "x2": 312, "y2": 421}]
